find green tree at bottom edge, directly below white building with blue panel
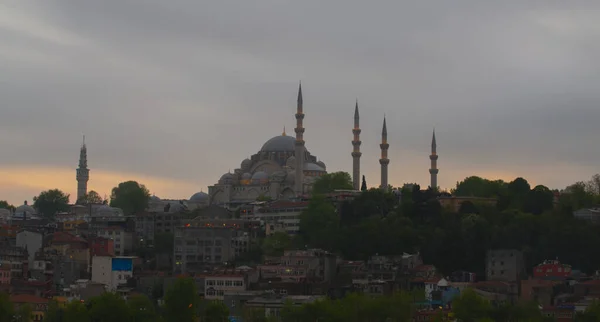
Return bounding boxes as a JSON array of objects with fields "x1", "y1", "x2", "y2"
[{"x1": 86, "y1": 292, "x2": 131, "y2": 322}]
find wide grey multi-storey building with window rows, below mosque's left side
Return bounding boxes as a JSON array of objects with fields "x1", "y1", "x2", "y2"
[{"x1": 173, "y1": 218, "x2": 261, "y2": 273}]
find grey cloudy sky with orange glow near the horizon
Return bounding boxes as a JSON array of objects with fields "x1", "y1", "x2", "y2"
[{"x1": 0, "y1": 0, "x2": 600, "y2": 204}]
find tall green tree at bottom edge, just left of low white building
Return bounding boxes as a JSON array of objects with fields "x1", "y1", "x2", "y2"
[{"x1": 164, "y1": 278, "x2": 200, "y2": 322}]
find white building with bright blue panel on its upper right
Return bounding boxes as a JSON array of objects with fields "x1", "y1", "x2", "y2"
[{"x1": 92, "y1": 256, "x2": 135, "y2": 291}]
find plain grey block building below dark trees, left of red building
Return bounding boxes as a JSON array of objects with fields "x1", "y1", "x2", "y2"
[{"x1": 485, "y1": 249, "x2": 525, "y2": 282}]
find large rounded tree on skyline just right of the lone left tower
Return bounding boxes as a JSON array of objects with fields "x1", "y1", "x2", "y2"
[{"x1": 110, "y1": 181, "x2": 150, "y2": 215}]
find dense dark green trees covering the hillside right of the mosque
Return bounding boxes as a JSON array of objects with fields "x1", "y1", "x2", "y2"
[{"x1": 292, "y1": 174, "x2": 600, "y2": 276}]
